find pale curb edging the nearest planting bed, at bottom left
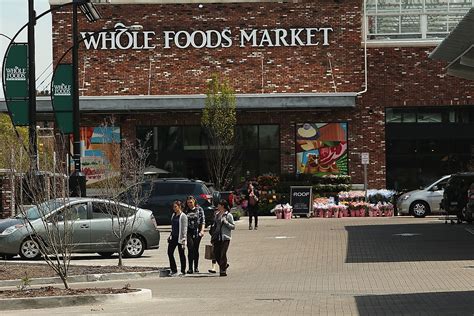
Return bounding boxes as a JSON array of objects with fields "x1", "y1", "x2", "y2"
[{"x1": 0, "y1": 289, "x2": 152, "y2": 310}]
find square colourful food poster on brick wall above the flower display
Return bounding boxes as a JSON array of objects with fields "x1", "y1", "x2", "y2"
[{"x1": 296, "y1": 123, "x2": 348, "y2": 176}]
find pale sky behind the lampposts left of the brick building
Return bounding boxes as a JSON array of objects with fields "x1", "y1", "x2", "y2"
[{"x1": 0, "y1": 0, "x2": 53, "y2": 99}]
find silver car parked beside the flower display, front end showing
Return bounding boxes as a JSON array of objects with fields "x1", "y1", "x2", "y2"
[{"x1": 397, "y1": 175, "x2": 451, "y2": 217}]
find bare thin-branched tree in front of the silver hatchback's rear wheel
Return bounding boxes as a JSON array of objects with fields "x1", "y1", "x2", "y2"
[{"x1": 90, "y1": 118, "x2": 151, "y2": 266}]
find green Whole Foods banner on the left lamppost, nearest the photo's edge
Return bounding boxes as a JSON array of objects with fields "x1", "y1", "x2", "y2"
[{"x1": 2, "y1": 43, "x2": 29, "y2": 126}]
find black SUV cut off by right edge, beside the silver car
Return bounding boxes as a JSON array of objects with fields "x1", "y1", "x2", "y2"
[{"x1": 441, "y1": 172, "x2": 474, "y2": 220}]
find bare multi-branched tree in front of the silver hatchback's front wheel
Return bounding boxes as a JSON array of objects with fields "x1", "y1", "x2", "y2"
[{"x1": 9, "y1": 136, "x2": 78, "y2": 289}]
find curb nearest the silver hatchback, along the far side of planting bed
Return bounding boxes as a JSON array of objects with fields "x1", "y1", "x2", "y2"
[{"x1": 0, "y1": 270, "x2": 163, "y2": 288}]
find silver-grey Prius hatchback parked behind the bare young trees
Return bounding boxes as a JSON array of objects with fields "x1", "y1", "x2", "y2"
[{"x1": 0, "y1": 198, "x2": 160, "y2": 259}]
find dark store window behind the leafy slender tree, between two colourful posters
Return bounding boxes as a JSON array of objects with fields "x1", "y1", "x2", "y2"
[{"x1": 137, "y1": 125, "x2": 280, "y2": 180}]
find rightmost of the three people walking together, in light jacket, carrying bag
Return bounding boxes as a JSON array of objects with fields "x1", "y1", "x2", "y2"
[{"x1": 211, "y1": 200, "x2": 235, "y2": 276}]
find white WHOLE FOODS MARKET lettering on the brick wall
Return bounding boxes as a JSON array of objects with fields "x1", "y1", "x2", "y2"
[{"x1": 81, "y1": 23, "x2": 333, "y2": 50}]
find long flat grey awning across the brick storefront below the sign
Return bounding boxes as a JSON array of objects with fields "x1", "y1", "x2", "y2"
[{"x1": 0, "y1": 92, "x2": 357, "y2": 112}]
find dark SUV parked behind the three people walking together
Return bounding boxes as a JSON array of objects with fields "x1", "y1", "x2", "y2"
[{"x1": 120, "y1": 178, "x2": 216, "y2": 226}]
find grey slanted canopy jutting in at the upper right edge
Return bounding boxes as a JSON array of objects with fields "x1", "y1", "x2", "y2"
[{"x1": 430, "y1": 8, "x2": 474, "y2": 80}]
